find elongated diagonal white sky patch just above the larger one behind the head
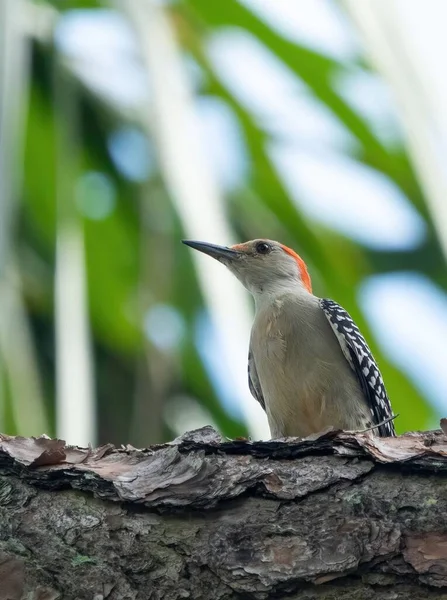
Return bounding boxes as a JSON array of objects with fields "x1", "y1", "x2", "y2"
[{"x1": 208, "y1": 28, "x2": 355, "y2": 149}]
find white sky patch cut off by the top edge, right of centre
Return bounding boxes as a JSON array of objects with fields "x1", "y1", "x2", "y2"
[{"x1": 241, "y1": 0, "x2": 359, "y2": 60}]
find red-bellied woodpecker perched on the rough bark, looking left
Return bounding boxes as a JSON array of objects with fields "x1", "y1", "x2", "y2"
[{"x1": 184, "y1": 240, "x2": 395, "y2": 438}]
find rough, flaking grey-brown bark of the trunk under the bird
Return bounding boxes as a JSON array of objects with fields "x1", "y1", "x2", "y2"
[{"x1": 0, "y1": 428, "x2": 447, "y2": 600}]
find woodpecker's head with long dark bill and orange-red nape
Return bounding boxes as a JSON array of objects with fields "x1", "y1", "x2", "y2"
[{"x1": 183, "y1": 239, "x2": 312, "y2": 296}]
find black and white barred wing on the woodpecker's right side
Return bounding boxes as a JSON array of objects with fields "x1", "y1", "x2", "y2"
[{"x1": 320, "y1": 299, "x2": 396, "y2": 437}]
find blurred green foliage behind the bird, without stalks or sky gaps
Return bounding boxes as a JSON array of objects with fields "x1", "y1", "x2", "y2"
[{"x1": 2, "y1": 0, "x2": 447, "y2": 445}]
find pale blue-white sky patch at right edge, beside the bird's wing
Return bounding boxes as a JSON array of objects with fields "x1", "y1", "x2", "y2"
[{"x1": 360, "y1": 272, "x2": 447, "y2": 416}]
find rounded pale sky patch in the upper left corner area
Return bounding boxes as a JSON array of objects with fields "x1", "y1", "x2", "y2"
[{"x1": 55, "y1": 10, "x2": 148, "y2": 110}]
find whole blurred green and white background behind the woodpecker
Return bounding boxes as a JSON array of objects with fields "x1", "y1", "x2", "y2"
[{"x1": 0, "y1": 0, "x2": 447, "y2": 446}]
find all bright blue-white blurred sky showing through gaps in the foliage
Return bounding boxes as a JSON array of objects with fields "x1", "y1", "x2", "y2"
[{"x1": 56, "y1": 0, "x2": 447, "y2": 432}]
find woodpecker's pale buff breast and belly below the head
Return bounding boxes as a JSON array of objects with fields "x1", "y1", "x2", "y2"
[{"x1": 251, "y1": 294, "x2": 363, "y2": 437}]
